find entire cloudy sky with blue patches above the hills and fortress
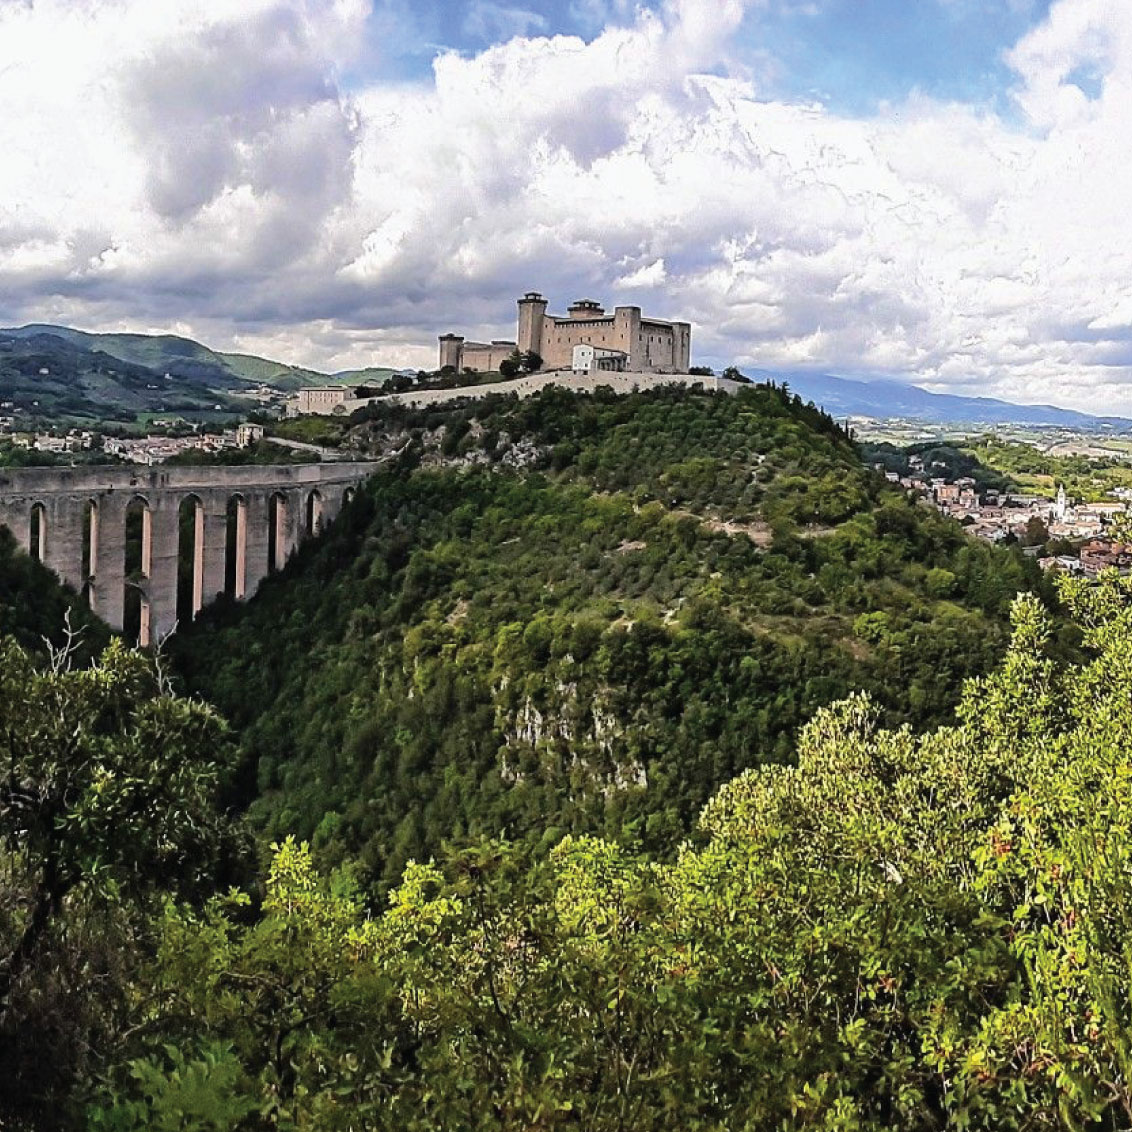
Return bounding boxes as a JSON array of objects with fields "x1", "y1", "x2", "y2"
[{"x1": 0, "y1": 0, "x2": 1132, "y2": 415}]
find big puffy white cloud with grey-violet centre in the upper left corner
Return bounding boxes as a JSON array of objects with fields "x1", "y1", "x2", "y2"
[{"x1": 0, "y1": 0, "x2": 365, "y2": 307}]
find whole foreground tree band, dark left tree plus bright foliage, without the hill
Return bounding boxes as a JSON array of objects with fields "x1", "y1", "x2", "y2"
[{"x1": 0, "y1": 504, "x2": 1132, "y2": 1132}]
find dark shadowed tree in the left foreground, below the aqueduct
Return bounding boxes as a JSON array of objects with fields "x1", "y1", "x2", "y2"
[{"x1": 0, "y1": 637, "x2": 235, "y2": 1126}]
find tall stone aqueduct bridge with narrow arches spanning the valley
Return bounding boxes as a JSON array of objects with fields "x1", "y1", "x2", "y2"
[{"x1": 0, "y1": 463, "x2": 378, "y2": 645}]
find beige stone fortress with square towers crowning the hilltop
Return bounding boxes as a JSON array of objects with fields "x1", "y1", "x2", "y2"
[{"x1": 440, "y1": 291, "x2": 692, "y2": 374}]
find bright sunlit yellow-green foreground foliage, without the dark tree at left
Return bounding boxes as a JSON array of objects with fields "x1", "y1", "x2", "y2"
[{"x1": 92, "y1": 575, "x2": 1132, "y2": 1132}]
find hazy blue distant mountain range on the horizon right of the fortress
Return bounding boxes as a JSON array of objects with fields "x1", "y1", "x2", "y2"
[{"x1": 745, "y1": 370, "x2": 1132, "y2": 431}]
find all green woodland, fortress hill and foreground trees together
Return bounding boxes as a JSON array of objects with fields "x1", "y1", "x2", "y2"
[{"x1": 0, "y1": 386, "x2": 1132, "y2": 1132}]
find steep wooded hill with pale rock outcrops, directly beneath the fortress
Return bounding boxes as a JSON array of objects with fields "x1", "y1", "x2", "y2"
[{"x1": 174, "y1": 386, "x2": 1050, "y2": 891}]
